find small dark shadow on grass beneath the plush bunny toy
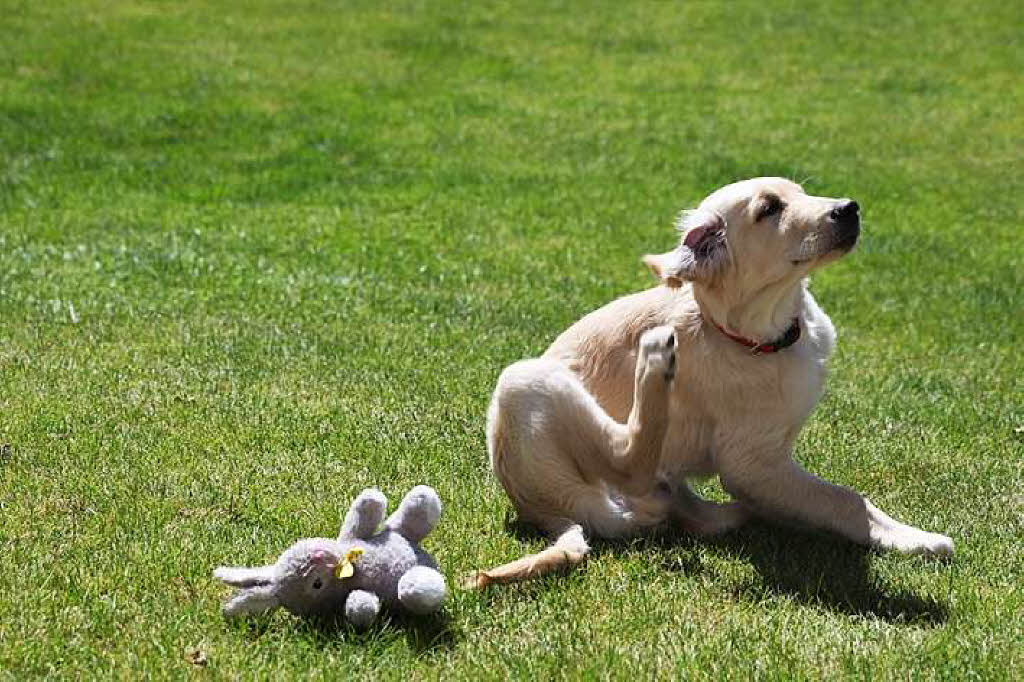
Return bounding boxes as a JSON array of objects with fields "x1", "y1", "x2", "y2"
[{"x1": 290, "y1": 611, "x2": 459, "y2": 655}]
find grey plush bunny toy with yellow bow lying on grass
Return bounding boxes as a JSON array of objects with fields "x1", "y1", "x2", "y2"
[{"x1": 213, "y1": 485, "x2": 445, "y2": 628}]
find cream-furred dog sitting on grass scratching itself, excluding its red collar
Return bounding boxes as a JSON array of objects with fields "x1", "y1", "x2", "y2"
[{"x1": 471, "y1": 178, "x2": 953, "y2": 587}]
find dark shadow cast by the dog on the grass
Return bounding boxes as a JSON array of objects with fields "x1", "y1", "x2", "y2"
[{"x1": 506, "y1": 512, "x2": 949, "y2": 625}]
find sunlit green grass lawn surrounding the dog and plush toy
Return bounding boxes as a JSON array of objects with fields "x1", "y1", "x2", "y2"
[{"x1": 0, "y1": 0, "x2": 1024, "y2": 680}]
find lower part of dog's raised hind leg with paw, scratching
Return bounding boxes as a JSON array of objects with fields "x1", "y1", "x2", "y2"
[{"x1": 607, "y1": 327, "x2": 676, "y2": 495}]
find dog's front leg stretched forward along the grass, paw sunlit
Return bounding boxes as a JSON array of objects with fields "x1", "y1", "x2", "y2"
[{"x1": 721, "y1": 456, "x2": 953, "y2": 556}]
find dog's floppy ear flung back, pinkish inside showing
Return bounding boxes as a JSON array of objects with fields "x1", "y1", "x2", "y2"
[{"x1": 643, "y1": 209, "x2": 729, "y2": 287}]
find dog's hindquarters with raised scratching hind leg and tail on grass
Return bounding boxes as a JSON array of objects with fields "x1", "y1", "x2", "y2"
[{"x1": 465, "y1": 327, "x2": 676, "y2": 588}]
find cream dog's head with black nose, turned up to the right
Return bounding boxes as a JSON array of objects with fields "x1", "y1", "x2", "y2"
[{"x1": 644, "y1": 177, "x2": 860, "y2": 290}]
